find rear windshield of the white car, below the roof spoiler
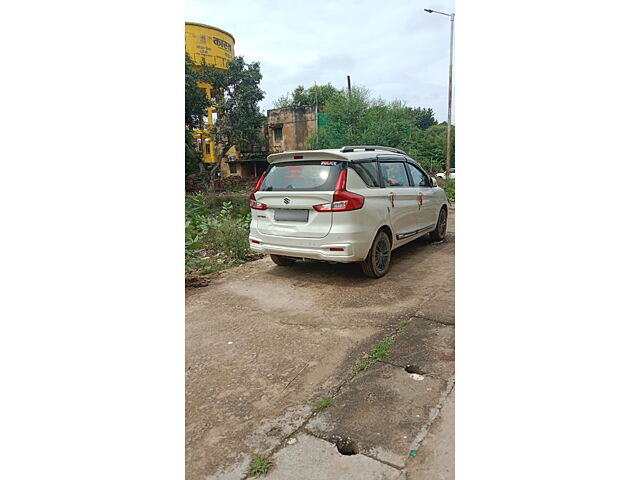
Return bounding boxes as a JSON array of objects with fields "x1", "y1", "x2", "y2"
[{"x1": 260, "y1": 160, "x2": 344, "y2": 192}]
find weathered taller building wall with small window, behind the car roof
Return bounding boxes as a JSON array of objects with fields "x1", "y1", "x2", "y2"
[{"x1": 267, "y1": 106, "x2": 316, "y2": 153}]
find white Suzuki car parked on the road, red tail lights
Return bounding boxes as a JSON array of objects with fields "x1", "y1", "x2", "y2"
[{"x1": 249, "y1": 146, "x2": 448, "y2": 278}]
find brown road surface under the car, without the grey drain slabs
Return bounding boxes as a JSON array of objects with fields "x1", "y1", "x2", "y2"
[{"x1": 185, "y1": 210, "x2": 455, "y2": 480}]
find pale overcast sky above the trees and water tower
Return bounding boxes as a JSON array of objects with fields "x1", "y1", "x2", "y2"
[{"x1": 185, "y1": 0, "x2": 455, "y2": 122}]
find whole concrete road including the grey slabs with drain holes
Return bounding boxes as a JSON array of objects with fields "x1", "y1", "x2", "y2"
[{"x1": 186, "y1": 208, "x2": 455, "y2": 480}]
